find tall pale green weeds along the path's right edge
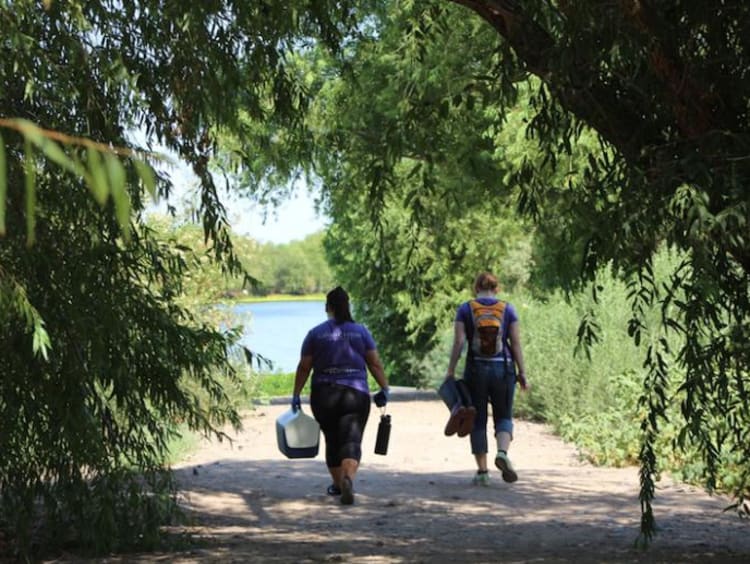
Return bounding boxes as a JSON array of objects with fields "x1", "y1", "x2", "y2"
[{"x1": 421, "y1": 252, "x2": 746, "y2": 490}]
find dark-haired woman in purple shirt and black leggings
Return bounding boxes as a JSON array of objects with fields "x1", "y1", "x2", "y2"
[{"x1": 292, "y1": 286, "x2": 388, "y2": 505}]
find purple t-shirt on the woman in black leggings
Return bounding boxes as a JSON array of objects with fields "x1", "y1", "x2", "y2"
[{"x1": 302, "y1": 319, "x2": 375, "y2": 394}]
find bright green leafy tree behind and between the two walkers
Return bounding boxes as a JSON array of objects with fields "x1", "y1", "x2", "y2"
[{"x1": 222, "y1": 3, "x2": 540, "y2": 384}]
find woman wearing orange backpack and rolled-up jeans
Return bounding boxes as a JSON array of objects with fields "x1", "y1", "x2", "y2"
[{"x1": 445, "y1": 272, "x2": 528, "y2": 486}]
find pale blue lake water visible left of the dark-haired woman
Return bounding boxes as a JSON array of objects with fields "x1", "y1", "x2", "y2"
[{"x1": 232, "y1": 301, "x2": 326, "y2": 372}]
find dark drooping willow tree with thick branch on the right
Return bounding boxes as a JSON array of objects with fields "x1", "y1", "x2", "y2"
[{"x1": 440, "y1": 0, "x2": 750, "y2": 535}]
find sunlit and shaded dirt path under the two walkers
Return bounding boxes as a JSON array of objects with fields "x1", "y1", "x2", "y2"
[{"x1": 109, "y1": 401, "x2": 750, "y2": 563}]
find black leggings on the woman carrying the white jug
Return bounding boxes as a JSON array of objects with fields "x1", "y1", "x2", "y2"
[{"x1": 310, "y1": 383, "x2": 370, "y2": 468}]
